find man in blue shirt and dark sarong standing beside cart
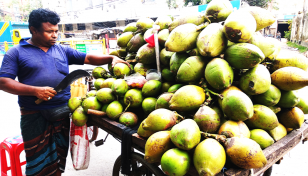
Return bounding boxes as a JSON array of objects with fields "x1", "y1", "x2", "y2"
[{"x1": 0, "y1": 9, "x2": 129, "y2": 176}]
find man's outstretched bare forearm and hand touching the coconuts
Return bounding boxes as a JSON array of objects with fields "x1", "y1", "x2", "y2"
[{"x1": 84, "y1": 54, "x2": 130, "y2": 67}]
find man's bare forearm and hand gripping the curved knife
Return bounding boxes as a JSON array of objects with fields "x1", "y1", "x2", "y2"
[{"x1": 0, "y1": 77, "x2": 57, "y2": 101}]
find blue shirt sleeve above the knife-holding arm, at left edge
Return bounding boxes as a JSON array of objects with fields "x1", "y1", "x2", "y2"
[{"x1": 0, "y1": 48, "x2": 18, "y2": 79}]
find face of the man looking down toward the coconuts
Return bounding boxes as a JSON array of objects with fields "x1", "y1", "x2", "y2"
[{"x1": 32, "y1": 22, "x2": 58, "y2": 47}]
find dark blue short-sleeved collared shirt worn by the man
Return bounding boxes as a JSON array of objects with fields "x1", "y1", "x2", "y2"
[{"x1": 0, "y1": 38, "x2": 86, "y2": 110}]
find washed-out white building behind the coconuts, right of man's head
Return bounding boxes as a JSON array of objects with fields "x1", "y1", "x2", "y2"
[{"x1": 42, "y1": 0, "x2": 190, "y2": 37}]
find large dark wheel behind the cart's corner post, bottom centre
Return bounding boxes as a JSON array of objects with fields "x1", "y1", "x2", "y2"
[{"x1": 112, "y1": 153, "x2": 165, "y2": 176}]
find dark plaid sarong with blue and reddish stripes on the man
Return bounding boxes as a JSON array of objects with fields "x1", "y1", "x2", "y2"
[{"x1": 20, "y1": 112, "x2": 70, "y2": 176}]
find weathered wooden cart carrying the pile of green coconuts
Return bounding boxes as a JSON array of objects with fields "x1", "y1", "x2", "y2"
[{"x1": 88, "y1": 110, "x2": 308, "y2": 176}]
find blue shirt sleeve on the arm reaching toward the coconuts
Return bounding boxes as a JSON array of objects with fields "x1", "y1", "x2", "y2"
[{"x1": 65, "y1": 47, "x2": 87, "y2": 65}]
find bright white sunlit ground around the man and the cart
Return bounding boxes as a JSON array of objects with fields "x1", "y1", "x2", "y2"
[{"x1": 0, "y1": 39, "x2": 308, "y2": 176}]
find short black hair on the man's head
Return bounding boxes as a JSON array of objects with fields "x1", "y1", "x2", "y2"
[{"x1": 29, "y1": 8, "x2": 60, "y2": 34}]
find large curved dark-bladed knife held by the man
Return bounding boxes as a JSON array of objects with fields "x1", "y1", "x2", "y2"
[{"x1": 35, "y1": 70, "x2": 90, "y2": 104}]
